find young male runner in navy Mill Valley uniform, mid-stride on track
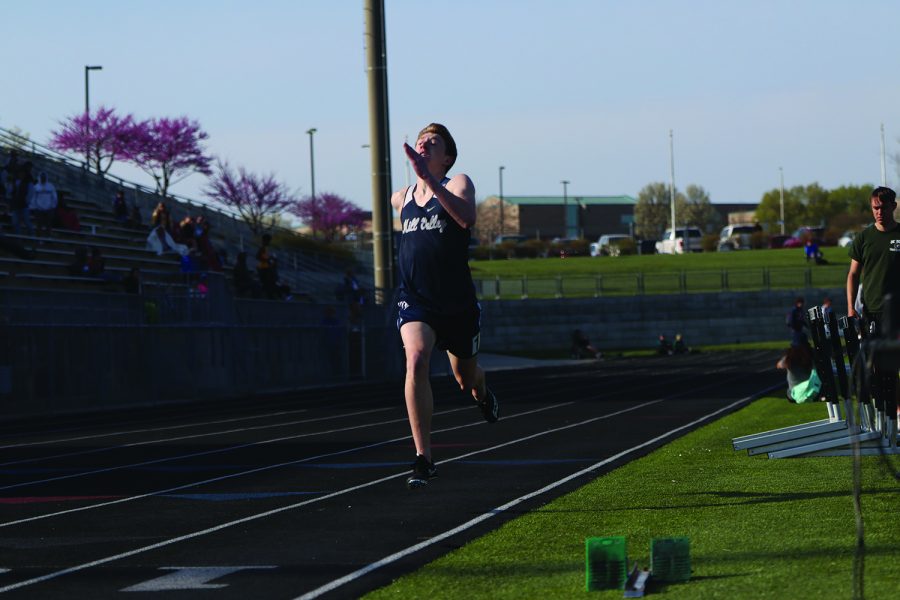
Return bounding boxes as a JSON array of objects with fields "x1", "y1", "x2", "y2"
[{"x1": 391, "y1": 123, "x2": 500, "y2": 489}]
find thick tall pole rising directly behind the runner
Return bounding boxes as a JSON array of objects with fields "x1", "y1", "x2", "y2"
[{"x1": 363, "y1": 0, "x2": 394, "y2": 304}]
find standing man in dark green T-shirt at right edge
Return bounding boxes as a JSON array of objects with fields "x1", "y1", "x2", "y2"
[{"x1": 847, "y1": 187, "x2": 900, "y2": 415}]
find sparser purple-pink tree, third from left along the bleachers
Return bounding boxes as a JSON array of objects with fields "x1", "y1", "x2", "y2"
[{"x1": 204, "y1": 162, "x2": 296, "y2": 235}]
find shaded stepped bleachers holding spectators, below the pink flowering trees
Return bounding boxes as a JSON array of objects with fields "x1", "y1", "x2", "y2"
[{"x1": 0, "y1": 138, "x2": 372, "y2": 302}]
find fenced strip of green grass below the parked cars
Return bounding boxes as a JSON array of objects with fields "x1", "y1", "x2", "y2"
[{"x1": 469, "y1": 247, "x2": 850, "y2": 299}]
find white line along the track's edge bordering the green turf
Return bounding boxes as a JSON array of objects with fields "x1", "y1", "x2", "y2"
[{"x1": 294, "y1": 384, "x2": 781, "y2": 600}]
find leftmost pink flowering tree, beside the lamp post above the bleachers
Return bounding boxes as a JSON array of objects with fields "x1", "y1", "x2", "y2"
[{"x1": 50, "y1": 106, "x2": 141, "y2": 175}]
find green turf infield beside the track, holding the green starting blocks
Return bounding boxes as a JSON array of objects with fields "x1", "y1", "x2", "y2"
[{"x1": 366, "y1": 397, "x2": 900, "y2": 600}]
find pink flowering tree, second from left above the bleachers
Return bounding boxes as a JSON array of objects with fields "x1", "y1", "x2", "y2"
[{"x1": 129, "y1": 117, "x2": 212, "y2": 198}]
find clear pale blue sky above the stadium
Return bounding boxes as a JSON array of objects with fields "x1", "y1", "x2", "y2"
[{"x1": 0, "y1": 0, "x2": 900, "y2": 209}]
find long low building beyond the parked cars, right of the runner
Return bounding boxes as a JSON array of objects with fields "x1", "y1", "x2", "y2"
[{"x1": 475, "y1": 196, "x2": 637, "y2": 242}]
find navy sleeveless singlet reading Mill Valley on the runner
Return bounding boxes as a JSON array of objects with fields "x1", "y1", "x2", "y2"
[{"x1": 398, "y1": 178, "x2": 477, "y2": 315}]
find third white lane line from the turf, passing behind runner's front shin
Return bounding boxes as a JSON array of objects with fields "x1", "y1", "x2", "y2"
[{"x1": 0, "y1": 402, "x2": 574, "y2": 528}]
